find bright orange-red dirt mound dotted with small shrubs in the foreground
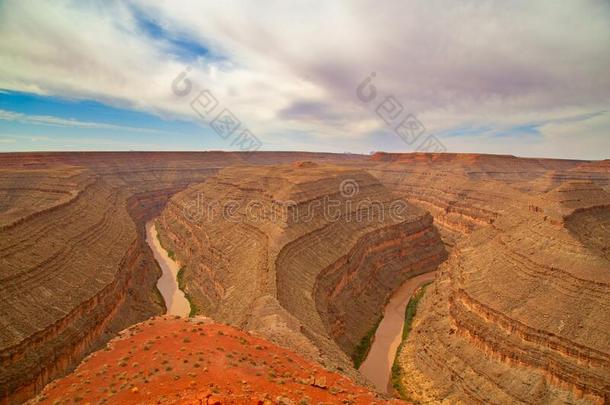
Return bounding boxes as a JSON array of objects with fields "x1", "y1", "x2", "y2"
[{"x1": 32, "y1": 316, "x2": 403, "y2": 404}]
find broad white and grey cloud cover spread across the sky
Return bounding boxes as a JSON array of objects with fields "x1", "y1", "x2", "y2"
[{"x1": 0, "y1": 0, "x2": 610, "y2": 156}]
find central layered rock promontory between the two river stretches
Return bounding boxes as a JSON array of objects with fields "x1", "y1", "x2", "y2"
[{"x1": 154, "y1": 165, "x2": 446, "y2": 375}]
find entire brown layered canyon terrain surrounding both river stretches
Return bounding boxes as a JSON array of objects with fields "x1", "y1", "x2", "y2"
[{"x1": 0, "y1": 152, "x2": 610, "y2": 404}]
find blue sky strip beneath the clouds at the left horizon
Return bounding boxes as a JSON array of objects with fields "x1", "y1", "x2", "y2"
[{"x1": 0, "y1": 90, "x2": 228, "y2": 152}]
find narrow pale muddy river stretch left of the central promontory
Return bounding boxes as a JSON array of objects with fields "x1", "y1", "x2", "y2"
[{"x1": 146, "y1": 221, "x2": 191, "y2": 317}]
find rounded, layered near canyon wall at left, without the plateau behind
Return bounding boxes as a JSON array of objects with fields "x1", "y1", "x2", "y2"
[{"x1": 0, "y1": 173, "x2": 160, "y2": 402}]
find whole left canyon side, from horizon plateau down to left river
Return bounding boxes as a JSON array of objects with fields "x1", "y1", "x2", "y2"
[{"x1": 0, "y1": 152, "x2": 364, "y2": 403}]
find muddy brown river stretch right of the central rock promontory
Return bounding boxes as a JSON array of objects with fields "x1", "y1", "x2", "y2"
[{"x1": 360, "y1": 272, "x2": 436, "y2": 392}]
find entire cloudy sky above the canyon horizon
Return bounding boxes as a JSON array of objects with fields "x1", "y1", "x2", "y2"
[{"x1": 0, "y1": 0, "x2": 610, "y2": 159}]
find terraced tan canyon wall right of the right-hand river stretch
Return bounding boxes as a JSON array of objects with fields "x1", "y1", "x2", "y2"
[{"x1": 380, "y1": 153, "x2": 610, "y2": 404}]
